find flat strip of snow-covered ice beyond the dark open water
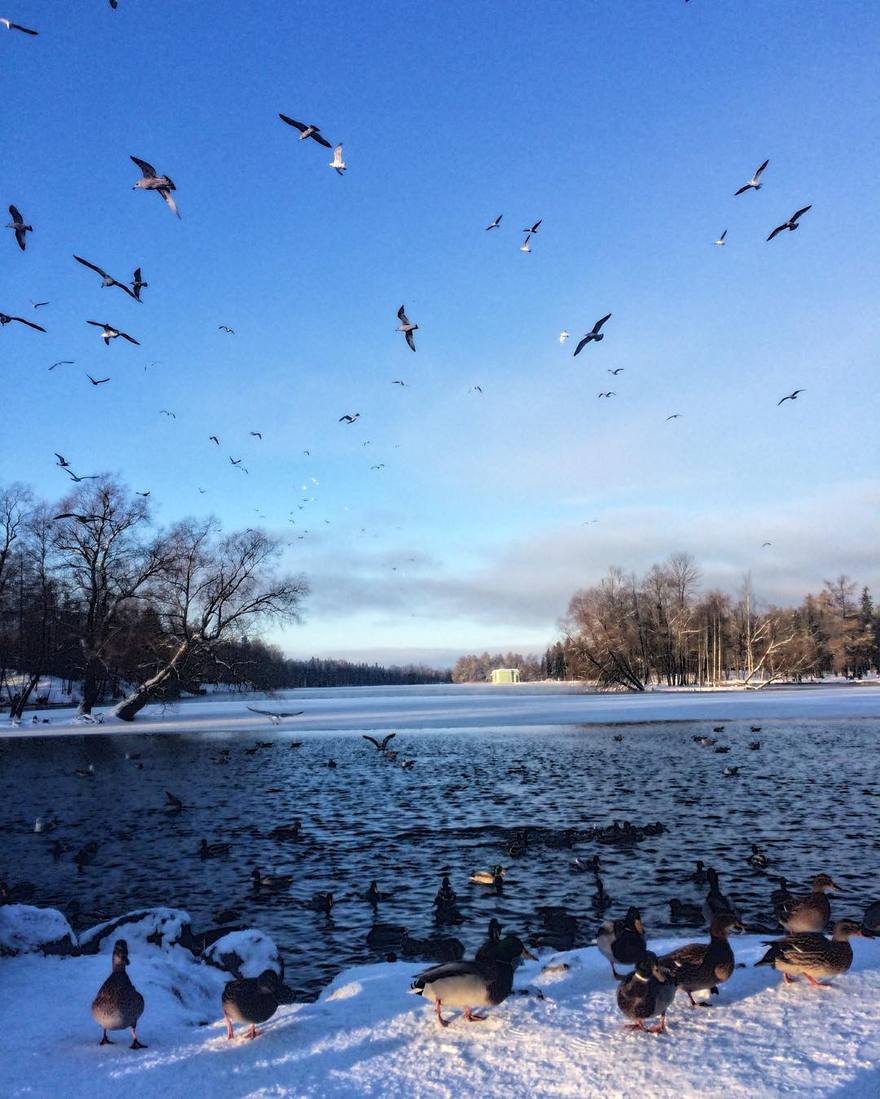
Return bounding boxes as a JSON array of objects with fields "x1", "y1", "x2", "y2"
[{"x1": 0, "y1": 684, "x2": 880, "y2": 736}]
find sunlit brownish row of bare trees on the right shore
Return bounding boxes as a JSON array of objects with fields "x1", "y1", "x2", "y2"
[{"x1": 542, "y1": 554, "x2": 880, "y2": 690}]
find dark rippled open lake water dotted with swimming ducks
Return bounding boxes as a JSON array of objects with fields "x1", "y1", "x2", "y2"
[{"x1": 0, "y1": 720, "x2": 880, "y2": 997}]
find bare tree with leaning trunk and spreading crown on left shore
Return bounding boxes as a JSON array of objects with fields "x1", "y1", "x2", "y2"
[{"x1": 114, "y1": 520, "x2": 308, "y2": 721}]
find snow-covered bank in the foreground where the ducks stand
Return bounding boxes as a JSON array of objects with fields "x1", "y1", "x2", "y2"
[{"x1": 0, "y1": 905, "x2": 880, "y2": 1099}]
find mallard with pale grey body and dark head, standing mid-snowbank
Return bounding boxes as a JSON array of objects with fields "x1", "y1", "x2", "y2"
[{"x1": 411, "y1": 935, "x2": 535, "y2": 1026}]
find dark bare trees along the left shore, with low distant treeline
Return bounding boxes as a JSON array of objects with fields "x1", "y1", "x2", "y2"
[{"x1": 0, "y1": 477, "x2": 448, "y2": 720}]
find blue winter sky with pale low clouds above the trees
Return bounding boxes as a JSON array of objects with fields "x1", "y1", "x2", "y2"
[{"x1": 0, "y1": 0, "x2": 880, "y2": 658}]
